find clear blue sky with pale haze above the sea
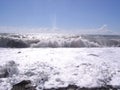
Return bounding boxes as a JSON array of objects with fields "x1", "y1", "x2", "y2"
[{"x1": 0, "y1": 0, "x2": 120, "y2": 33}]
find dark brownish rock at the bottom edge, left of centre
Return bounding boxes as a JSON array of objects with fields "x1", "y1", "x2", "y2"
[{"x1": 11, "y1": 80, "x2": 36, "y2": 90}]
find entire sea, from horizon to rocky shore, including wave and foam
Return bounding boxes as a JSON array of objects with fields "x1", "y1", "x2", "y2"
[{"x1": 0, "y1": 33, "x2": 120, "y2": 90}]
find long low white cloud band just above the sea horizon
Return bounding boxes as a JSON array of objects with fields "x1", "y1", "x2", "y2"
[{"x1": 0, "y1": 24, "x2": 119, "y2": 35}]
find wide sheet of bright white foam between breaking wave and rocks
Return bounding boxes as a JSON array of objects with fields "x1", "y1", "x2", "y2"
[{"x1": 0, "y1": 48, "x2": 120, "y2": 90}]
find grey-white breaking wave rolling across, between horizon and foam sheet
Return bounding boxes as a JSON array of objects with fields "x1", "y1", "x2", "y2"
[{"x1": 0, "y1": 34, "x2": 120, "y2": 48}]
